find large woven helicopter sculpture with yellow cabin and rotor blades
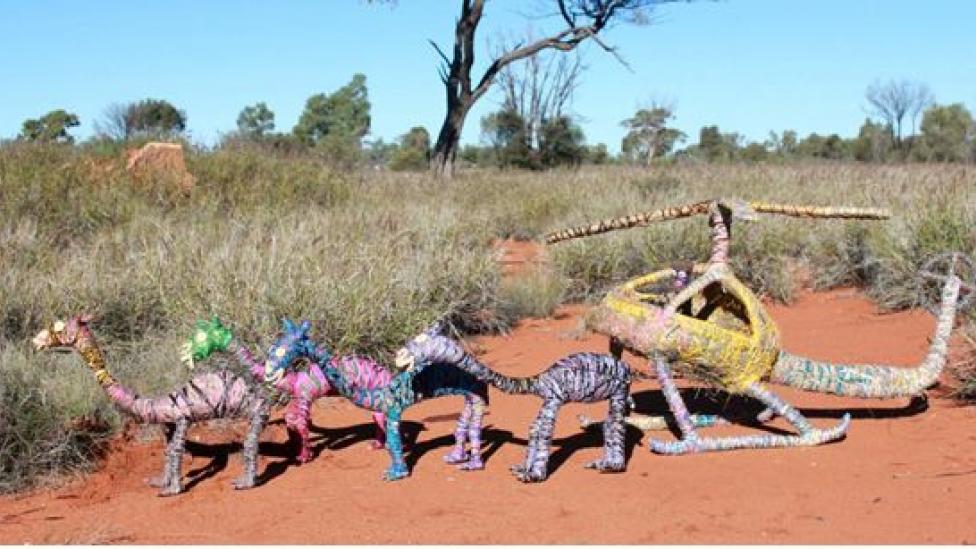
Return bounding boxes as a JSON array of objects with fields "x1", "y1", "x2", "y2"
[{"x1": 547, "y1": 200, "x2": 961, "y2": 454}]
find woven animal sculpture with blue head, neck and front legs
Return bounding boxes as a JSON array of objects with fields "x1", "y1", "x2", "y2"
[{"x1": 265, "y1": 322, "x2": 488, "y2": 480}]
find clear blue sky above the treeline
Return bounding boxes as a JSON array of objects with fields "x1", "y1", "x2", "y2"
[{"x1": 0, "y1": 0, "x2": 976, "y2": 150}]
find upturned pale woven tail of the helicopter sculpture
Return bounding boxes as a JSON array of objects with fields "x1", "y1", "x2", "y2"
[{"x1": 770, "y1": 276, "x2": 960, "y2": 398}]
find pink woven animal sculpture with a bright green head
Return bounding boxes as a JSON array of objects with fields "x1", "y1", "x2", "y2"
[{"x1": 183, "y1": 316, "x2": 393, "y2": 463}]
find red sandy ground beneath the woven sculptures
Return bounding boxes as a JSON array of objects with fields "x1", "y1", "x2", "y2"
[{"x1": 0, "y1": 268, "x2": 976, "y2": 544}]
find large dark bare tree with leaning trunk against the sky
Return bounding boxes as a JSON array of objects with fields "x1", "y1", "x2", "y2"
[{"x1": 431, "y1": 0, "x2": 680, "y2": 177}]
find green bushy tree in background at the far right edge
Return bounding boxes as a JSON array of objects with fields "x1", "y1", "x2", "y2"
[{"x1": 914, "y1": 103, "x2": 976, "y2": 162}]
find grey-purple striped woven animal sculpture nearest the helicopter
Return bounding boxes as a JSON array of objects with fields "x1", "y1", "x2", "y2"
[{"x1": 396, "y1": 334, "x2": 631, "y2": 482}]
